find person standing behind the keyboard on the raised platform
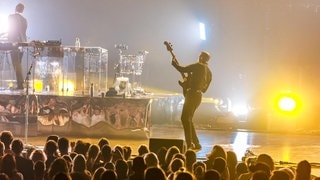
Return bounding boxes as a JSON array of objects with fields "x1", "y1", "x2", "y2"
[{"x1": 8, "y1": 3, "x2": 28, "y2": 89}]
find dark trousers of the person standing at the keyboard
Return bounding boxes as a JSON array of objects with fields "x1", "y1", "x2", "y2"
[{"x1": 11, "y1": 49, "x2": 23, "y2": 89}]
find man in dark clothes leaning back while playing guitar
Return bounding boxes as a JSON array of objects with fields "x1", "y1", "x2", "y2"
[{"x1": 172, "y1": 51, "x2": 212, "y2": 150}]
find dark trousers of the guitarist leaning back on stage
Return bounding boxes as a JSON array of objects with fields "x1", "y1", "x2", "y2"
[{"x1": 181, "y1": 90, "x2": 202, "y2": 148}]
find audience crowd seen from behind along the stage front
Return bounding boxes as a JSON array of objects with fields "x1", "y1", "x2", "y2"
[{"x1": 0, "y1": 131, "x2": 320, "y2": 180}]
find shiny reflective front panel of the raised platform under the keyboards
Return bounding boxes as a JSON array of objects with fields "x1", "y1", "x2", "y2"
[{"x1": 0, "y1": 94, "x2": 151, "y2": 137}]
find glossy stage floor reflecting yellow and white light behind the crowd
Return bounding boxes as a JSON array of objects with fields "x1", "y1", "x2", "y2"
[{"x1": 16, "y1": 125, "x2": 320, "y2": 176}]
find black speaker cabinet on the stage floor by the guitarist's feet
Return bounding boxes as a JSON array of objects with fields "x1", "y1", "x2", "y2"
[{"x1": 149, "y1": 138, "x2": 186, "y2": 153}]
